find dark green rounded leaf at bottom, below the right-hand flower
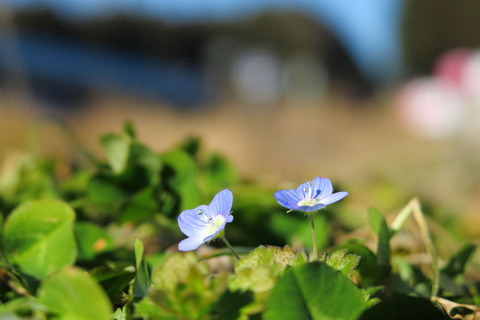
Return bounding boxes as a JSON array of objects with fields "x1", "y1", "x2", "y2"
[{"x1": 265, "y1": 262, "x2": 365, "y2": 320}]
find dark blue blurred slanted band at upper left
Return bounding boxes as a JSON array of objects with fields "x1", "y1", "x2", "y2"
[{"x1": 0, "y1": 32, "x2": 208, "y2": 107}]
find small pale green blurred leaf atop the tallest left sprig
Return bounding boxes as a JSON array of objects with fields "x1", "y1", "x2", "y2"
[{"x1": 100, "y1": 133, "x2": 131, "y2": 174}]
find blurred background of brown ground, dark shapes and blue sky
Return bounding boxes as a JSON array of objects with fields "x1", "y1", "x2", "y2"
[{"x1": 0, "y1": 0, "x2": 480, "y2": 239}]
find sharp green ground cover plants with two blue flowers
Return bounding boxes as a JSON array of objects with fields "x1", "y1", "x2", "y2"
[{"x1": 0, "y1": 124, "x2": 480, "y2": 320}]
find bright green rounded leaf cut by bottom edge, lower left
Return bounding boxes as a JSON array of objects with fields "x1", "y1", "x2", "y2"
[{"x1": 38, "y1": 267, "x2": 112, "y2": 320}]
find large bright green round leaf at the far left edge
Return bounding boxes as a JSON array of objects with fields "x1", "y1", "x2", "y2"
[{"x1": 4, "y1": 200, "x2": 77, "y2": 278}]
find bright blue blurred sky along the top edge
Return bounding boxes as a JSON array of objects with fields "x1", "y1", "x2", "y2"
[{"x1": 12, "y1": 0, "x2": 404, "y2": 84}]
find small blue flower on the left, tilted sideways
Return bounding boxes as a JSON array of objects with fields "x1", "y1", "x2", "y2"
[{"x1": 178, "y1": 189, "x2": 233, "y2": 251}]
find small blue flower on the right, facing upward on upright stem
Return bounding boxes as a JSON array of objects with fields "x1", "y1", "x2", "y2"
[{"x1": 274, "y1": 177, "x2": 348, "y2": 212}]
